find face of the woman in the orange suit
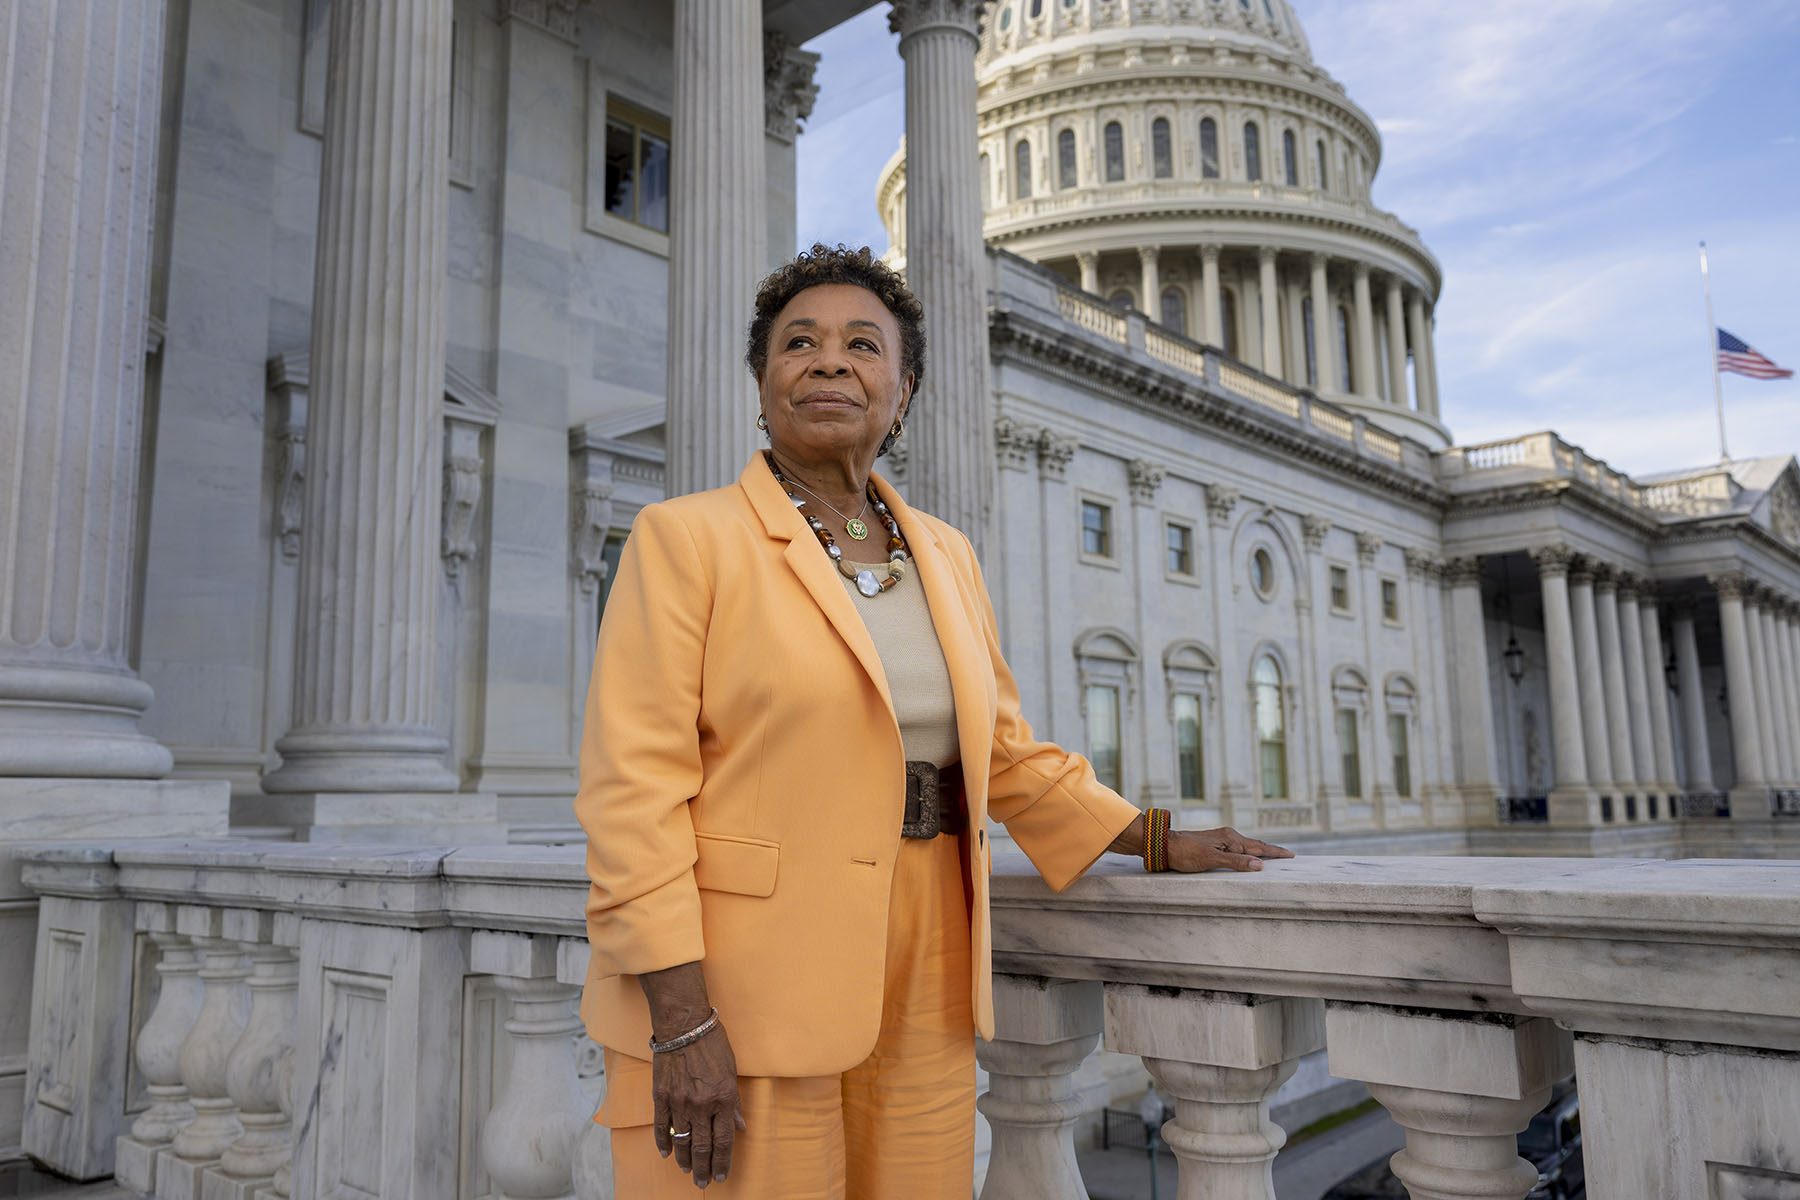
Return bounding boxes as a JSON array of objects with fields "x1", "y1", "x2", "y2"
[{"x1": 758, "y1": 282, "x2": 913, "y2": 471}]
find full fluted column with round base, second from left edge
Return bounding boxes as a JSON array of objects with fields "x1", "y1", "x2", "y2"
[{"x1": 263, "y1": 0, "x2": 464, "y2": 792}]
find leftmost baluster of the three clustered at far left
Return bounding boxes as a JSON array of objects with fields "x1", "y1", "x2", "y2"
[{"x1": 113, "y1": 901, "x2": 202, "y2": 1195}]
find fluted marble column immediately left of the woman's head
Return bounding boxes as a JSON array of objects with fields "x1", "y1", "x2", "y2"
[{"x1": 666, "y1": 0, "x2": 766, "y2": 497}]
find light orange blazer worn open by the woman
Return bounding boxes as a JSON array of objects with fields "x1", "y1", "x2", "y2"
[{"x1": 574, "y1": 453, "x2": 1138, "y2": 1076}]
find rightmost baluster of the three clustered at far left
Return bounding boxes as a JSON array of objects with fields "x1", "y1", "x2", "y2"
[{"x1": 212, "y1": 909, "x2": 301, "y2": 1200}]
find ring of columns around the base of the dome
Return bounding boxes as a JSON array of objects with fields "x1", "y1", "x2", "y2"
[{"x1": 1072, "y1": 241, "x2": 1438, "y2": 419}]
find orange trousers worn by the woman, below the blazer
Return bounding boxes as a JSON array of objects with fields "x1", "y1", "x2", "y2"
[{"x1": 596, "y1": 835, "x2": 976, "y2": 1200}]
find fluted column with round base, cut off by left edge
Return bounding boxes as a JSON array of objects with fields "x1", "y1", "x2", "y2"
[{"x1": 0, "y1": 0, "x2": 173, "y2": 780}]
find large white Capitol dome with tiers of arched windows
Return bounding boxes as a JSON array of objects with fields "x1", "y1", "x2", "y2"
[{"x1": 877, "y1": 0, "x2": 1451, "y2": 448}]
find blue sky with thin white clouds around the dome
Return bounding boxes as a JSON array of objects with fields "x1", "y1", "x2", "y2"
[{"x1": 799, "y1": 0, "x2": 1800, "y2": 473}]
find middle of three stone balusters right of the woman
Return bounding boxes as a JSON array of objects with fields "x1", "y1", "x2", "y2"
[{"x1": 1105, "y1": 984, "x2": 1325, "y2": 1200}]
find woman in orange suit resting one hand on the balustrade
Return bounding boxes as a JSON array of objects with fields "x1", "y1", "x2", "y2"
[{"x1": 576, "y1": 246, "x2": 1289, "y2": 1200}]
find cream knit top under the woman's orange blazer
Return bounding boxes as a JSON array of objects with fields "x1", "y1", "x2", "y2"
[{"x1": 839, "y1": 556, "x2": 961, "y2": 766}]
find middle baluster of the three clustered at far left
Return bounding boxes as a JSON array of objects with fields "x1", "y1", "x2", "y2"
[{"x1": 157, "y1": 905, "x2": 250, "y2": 1200}]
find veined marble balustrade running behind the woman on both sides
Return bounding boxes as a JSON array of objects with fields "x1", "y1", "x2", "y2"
[{"x1": 22, "y1": 840, "x2": 1800, "y2": 1200}]
